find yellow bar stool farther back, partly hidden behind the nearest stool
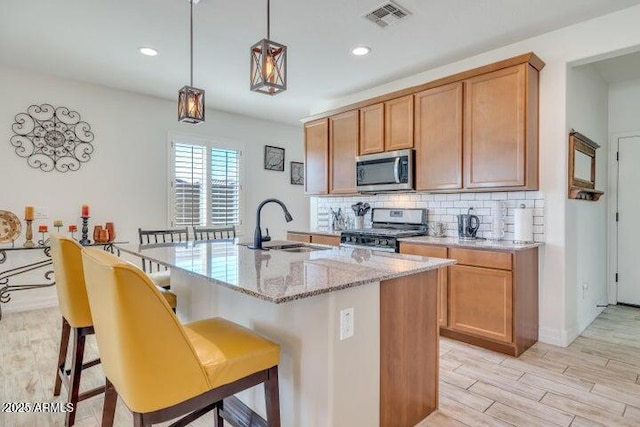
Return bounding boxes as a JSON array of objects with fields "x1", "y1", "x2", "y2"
[{"x1": 51, "y1": 234, "x2": 176, "y2": 426}]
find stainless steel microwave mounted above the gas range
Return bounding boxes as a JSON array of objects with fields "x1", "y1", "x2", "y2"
[{"x1": 356, "y1": 150, "x2": 414, "y2": 192}]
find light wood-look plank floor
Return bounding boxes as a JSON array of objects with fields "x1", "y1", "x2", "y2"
[{"x1": 0, "y1": 307, "x2": 640, "y2": 427}]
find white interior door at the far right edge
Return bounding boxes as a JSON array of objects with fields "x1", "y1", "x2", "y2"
[{"x1": 617, "y1": 136, "x2": 640, "y2": 306}]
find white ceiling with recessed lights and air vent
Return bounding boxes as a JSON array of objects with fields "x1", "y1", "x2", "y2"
[{"x1": 0, "y1": 0, "x2": 640, "y2": 124}]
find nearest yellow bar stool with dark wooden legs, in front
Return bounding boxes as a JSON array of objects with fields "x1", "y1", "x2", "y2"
[{"x1": 82, "y1": 248, "x2": 280, "y2": 427}]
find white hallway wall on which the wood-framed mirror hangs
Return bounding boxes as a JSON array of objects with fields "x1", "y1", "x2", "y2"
[{"x1": 565, "y1": 65, "x2": 609, "y2": 333}]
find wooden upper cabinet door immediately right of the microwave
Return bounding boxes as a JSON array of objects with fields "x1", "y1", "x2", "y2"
[{"x1": 414, "y1": 82, "x2": 462, "y2": 190}]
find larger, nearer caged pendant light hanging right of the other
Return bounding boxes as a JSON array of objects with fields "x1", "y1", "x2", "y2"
[{"x1": 251, "y1": 0, "x2": 287, "y2": 95}]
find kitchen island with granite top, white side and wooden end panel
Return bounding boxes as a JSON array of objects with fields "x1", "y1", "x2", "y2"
[{"x1": 118, "y1": 241, "x2": 455, "y2": 427}]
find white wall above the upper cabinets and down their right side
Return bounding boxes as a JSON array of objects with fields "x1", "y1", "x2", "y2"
[{"x1": 312, "y1": 6, "x2": 640, "y2": 345}]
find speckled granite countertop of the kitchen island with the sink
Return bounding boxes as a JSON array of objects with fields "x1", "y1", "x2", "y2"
[{"x1": 116, "y1": 240, "x2": 455, "y2": 303}]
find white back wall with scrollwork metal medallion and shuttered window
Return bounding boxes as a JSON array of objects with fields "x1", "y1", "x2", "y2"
[{"x1": 0, "y1": 63, "x2": 309, "y2": 310}]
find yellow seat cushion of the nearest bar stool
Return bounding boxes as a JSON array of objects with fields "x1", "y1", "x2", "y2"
[{"x1": 184, "y1": 317, "x2": 280, "y2": 388}]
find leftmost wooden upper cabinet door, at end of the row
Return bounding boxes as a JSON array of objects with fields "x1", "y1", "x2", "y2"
[{"x1": 304, "y1": 119, "x2": 329, "y2": 194}]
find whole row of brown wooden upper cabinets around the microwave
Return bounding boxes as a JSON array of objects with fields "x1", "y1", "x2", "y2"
[{"x1": 305, "y1": 53, "x2": 544, "y2": 194}]
